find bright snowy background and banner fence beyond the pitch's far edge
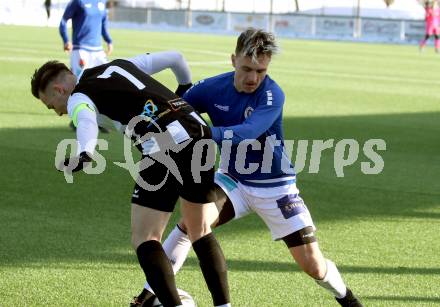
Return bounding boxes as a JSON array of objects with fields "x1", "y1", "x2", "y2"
[{"x1": 0, "y1": 0, "x2": 425, "y2": 43}]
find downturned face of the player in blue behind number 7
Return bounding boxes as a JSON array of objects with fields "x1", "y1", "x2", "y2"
[{"x1": 231, "y1": 54, "x2": 270, "y2": 93}]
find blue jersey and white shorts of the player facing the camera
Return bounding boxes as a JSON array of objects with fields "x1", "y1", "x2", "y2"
[{"x1": 183, "y1": 72, "x2": 315, "y2": 240}]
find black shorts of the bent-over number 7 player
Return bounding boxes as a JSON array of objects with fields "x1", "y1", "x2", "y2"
[{"x1": 131, "y1": 117, "x2": 216, "y2": 212}]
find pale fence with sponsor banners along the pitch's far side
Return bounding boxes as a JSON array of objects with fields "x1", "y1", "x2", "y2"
[{"x1": 0, "y1": 0, "x2": 424, "y2": 43}]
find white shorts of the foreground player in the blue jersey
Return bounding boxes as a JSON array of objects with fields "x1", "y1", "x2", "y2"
[{"x1": 215, "y1": 171, "x2": 316, "y2": 240}]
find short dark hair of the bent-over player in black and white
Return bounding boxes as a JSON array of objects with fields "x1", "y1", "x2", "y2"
[{"x1": 31, "y1": 61, "x2": 70, "y2": 98}]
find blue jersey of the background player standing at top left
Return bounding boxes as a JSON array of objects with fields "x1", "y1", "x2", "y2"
[{"x1": 59, "y1": 0, "x2": 112, "y2": 51}]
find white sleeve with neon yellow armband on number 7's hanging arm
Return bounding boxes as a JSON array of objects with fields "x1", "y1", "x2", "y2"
[{"x1": 67, "y1": 93, "x2": 98, "y2": 154}]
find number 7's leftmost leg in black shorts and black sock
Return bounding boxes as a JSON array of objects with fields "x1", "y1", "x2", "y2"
[{"x1": 132, "y1": 157, "x2": 185, "y2": 306}]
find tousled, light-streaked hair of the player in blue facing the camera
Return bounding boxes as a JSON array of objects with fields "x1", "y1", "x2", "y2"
[{"x1": 235, "y1": 28, "x2": 278, "y2": 62}]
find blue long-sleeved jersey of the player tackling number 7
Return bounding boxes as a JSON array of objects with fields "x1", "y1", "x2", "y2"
[{"x1": 183, "y1": 72, "x2": 295, "y2": 187}]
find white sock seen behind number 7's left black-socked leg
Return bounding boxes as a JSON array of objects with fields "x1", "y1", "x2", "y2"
[{"x1": 144, "y1": 225, "x2": 192, "y2": 293}]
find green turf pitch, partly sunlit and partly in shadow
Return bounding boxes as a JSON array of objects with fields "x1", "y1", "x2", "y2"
[{"x1": 0, "y1": 26, "x2": 440, "y2": 307}]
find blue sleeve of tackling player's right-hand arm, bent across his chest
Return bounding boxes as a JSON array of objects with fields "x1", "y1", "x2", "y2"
[{"x1": 211, "y1": 87, "x2": 285, "y2": 144}]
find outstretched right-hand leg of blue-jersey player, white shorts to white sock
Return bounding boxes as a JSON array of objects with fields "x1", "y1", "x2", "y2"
[{"x1": 246, "y1": 189, "x2": 362, "y2": 307}]
